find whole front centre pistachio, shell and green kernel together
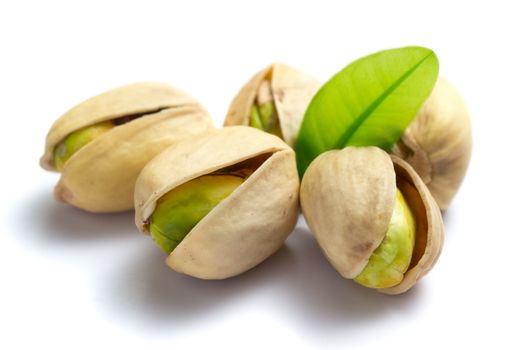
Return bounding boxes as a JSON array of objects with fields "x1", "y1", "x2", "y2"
[{"x1": 135, "y1": 126, "x2": 299, "y2": 279}]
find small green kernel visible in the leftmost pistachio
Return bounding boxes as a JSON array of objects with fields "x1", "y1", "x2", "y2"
[{"x1": 53, "y1": 121, "x2": 115, "y2": 171}]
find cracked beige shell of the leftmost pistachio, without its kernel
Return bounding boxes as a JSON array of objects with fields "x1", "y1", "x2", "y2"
[{"x1": 40, "y1": 82, "x2": 213, "y2": 212}]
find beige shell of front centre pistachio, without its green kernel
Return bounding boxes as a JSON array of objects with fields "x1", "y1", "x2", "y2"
[{"x1": 135, "y1": 126, "x2": 299, "y2": 279}]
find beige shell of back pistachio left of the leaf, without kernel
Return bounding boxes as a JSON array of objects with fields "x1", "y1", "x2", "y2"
[{"x1": 224, "y1": 63, "x2": 321, "y2": 147}]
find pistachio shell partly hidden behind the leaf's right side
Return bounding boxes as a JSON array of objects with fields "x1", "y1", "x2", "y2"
[{"x1": 393, "y1": 78, "x2": 472, "y2": 209}]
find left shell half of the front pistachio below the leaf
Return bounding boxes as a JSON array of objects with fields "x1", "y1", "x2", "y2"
[{"x1": 300, "y1": 147, "x2": 396, "y2": 278}]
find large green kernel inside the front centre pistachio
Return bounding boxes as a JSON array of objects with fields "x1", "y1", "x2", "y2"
[{"x1": 149, "y1": 175, "x2": 244, "y2": 254}]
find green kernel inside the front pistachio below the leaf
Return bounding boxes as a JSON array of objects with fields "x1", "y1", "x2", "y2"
[{"x1": 354, "y1": 189, "x2": 416, "y2": 288}]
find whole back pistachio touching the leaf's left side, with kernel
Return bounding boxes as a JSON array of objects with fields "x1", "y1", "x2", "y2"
[{"x1": 224, "y1": 63, "x2": 321, "y2": 147}]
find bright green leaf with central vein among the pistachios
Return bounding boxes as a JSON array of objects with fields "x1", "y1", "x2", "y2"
[{"x1": 296, "y1": 46, "x2": 439, "y2": 176}]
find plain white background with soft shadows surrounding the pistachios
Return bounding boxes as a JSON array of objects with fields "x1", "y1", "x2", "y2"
[{"x1": 0, "y1": 0, "x2": 525, "y2": 349}]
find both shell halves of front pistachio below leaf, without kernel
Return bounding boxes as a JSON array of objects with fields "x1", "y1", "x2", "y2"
[{"x1": 300, "y1": 147, "x2": 443, "y2": 294}]
